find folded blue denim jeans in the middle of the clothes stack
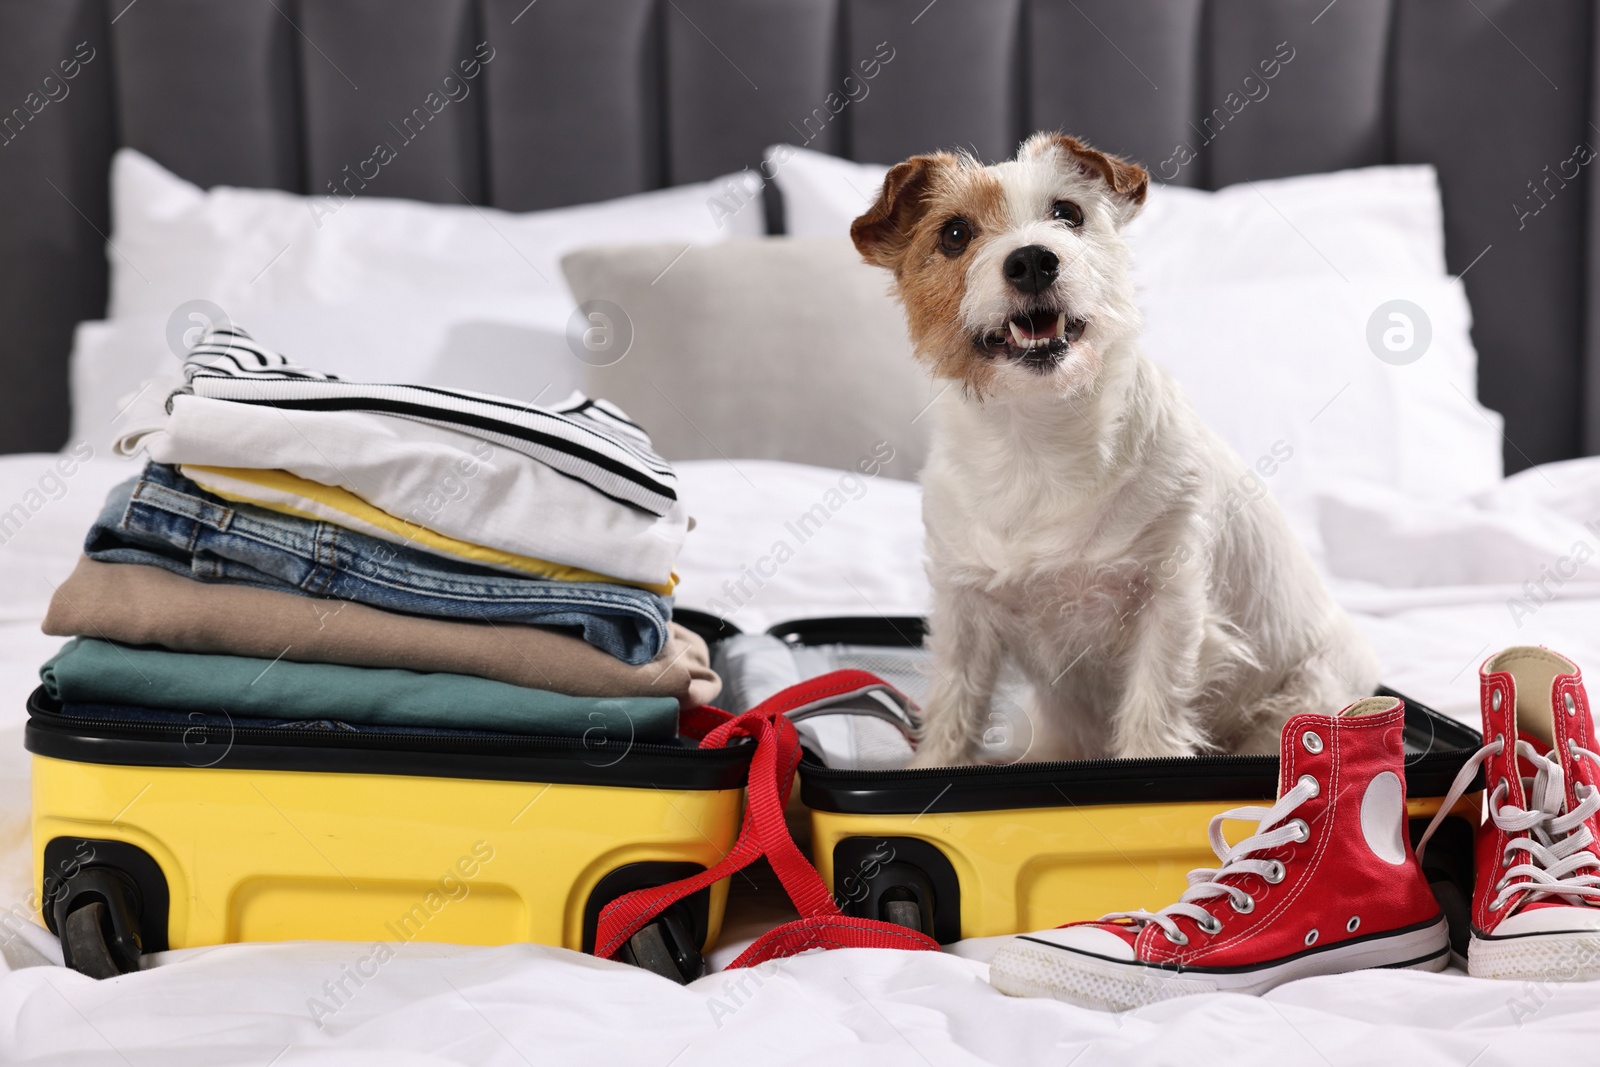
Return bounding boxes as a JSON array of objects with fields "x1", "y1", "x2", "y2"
[{"x1": 83, "y1": 462, "x2": 672, "y2": 664}]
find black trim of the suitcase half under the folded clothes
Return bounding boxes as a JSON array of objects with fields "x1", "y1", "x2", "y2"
[{"x1": 22, "y1": 688, "x2": 755, "y2": 790}]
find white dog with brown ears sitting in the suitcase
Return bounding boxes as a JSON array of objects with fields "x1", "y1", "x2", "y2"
[{"x1": 851, "y1": 134, "x2": 1378, "y2": 766}]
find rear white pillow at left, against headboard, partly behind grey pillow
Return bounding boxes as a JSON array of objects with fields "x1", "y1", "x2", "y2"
[{"x1": 107, "y1": 149, "x2": 765, "y2": 321}]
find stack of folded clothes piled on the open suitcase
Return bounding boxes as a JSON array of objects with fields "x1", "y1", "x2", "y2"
[{"x1": 42, "y1": 328, "x2": 720, "y2": 741}]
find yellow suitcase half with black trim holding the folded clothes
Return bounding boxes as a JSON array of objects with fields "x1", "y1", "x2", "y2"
[{"x1": 26, "y1": 689, "x2": 750, "y2": 977}]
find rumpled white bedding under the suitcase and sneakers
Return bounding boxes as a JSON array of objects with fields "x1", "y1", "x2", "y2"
[{"x1": 0, "y1": 454, "x2": 1600, "y2": 1067}]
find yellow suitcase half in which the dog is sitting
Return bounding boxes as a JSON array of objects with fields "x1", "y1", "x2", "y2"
[{"x1": 717, "y1": 617, "x2": 1480, "y2": 949}]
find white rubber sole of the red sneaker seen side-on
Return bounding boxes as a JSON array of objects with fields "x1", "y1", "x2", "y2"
[{"x1": 989, "y1": 918, "x2": 1450, "y2": 1011}]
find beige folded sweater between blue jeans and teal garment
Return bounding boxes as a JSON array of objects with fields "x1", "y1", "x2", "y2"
[{"x1": 43, "y1": 558, "x2": 722, "y2": 707}]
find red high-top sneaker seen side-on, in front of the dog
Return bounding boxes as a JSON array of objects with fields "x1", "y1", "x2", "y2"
[{"x1": 989, "y1": 697, "x2": 1450, "y2": 1011}]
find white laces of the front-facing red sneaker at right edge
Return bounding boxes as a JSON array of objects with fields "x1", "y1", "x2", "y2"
[{"x1": 1416, "y1": 736, "x2": 1600, "y2": 909}]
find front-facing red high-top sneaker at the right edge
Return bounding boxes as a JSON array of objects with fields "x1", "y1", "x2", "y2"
[{"x1": 1418, "y1": 646, "x2": 1600, "y2": 982}]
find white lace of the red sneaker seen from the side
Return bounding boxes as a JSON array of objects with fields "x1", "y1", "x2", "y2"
[{"x1": 1099, "y1": 774, "x2": 1318, "y2": 945}]
